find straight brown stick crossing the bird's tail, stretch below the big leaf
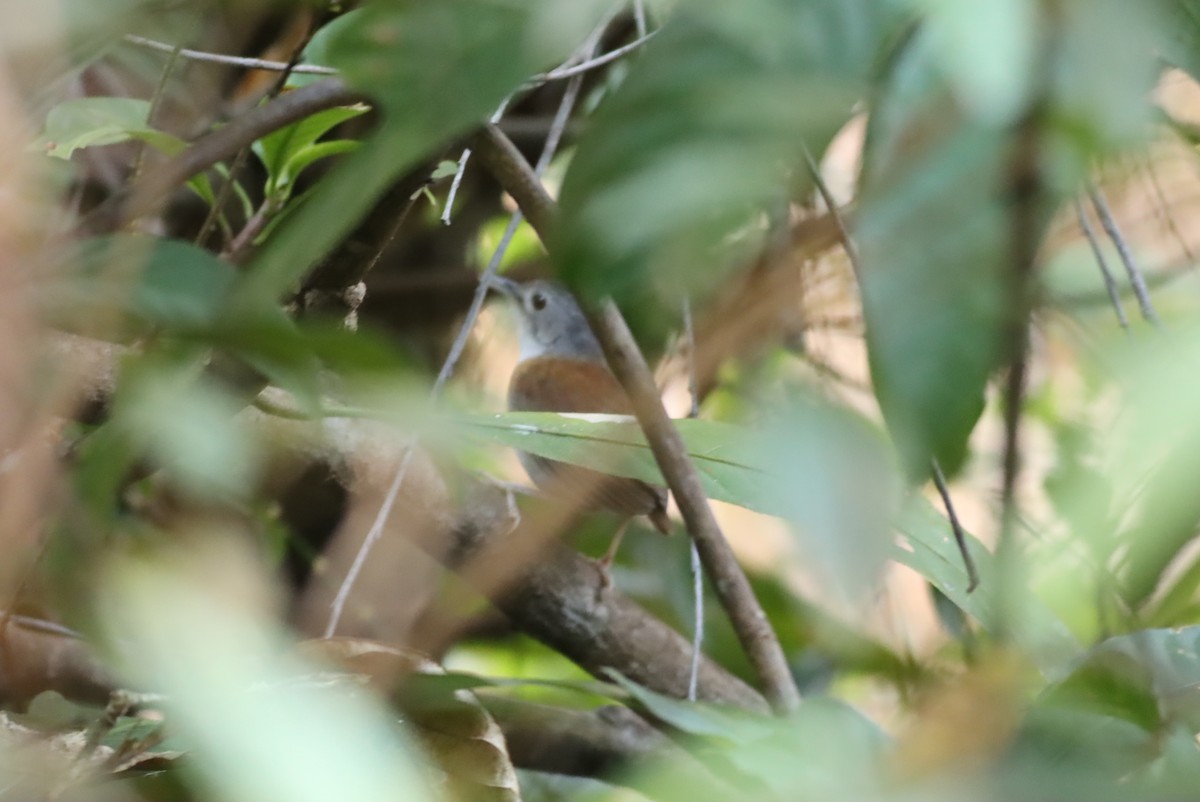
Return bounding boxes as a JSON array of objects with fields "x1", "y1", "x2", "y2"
[{"x1": 589, "y1": 299, "x2": 800, "y2": 713}]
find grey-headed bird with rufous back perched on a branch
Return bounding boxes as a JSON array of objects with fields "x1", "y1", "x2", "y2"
[{"x1": 491, "y1": 276, "x2": 671, "y2": 576}]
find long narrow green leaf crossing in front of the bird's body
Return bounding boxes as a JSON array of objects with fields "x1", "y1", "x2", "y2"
[{"x1": 462, "y1": 412, "x2": 1079, "y2": 638}]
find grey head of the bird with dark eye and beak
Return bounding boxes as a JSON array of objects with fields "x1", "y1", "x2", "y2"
[{"x1": 492, "y1": 276, "x2": 604, "y2": 360}]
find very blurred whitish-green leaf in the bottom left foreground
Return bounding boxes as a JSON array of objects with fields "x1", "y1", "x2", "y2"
[{"x1": 98, "y1": 547, "x2": 437, "y2": 802}]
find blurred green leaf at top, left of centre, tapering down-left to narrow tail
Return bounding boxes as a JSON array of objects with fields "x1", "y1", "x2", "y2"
[{"x1": 239, "y1": 0, "x2": 607, "y2": 303}]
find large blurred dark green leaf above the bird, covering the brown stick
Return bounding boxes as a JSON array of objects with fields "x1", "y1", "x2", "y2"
[{"x1": 551, "y1": 0, "x2": 898, "y2": 328}]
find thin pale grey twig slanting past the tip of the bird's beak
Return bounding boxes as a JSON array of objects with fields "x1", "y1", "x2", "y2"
[{"x1": 325, "y1": 62, "x2": 582, "y2": 638}]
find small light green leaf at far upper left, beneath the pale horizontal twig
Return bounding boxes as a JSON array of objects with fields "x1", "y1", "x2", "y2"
[{"x1": 38, "y1": 97, "x2": 187, "y2": 158}]
